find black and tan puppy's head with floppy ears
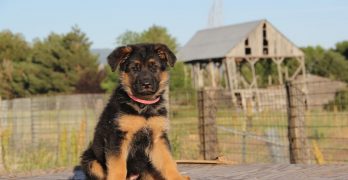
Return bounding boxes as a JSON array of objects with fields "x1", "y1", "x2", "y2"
[{"x1": 108, "y1": 44, "x2": 176, "y2": 99}]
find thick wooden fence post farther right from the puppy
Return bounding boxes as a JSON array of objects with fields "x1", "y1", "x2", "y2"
[{"x1": 285, "y1": 81, "x2": 310, "y2": 164}]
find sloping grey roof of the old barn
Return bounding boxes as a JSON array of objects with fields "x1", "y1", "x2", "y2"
[{"x1": 178, "y1": 20, "x2": 265, "y2": 61}]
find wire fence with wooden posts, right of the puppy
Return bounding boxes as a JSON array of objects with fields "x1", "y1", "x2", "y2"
[{"x1": 198, "y1": 81, "x2": 348, "y2": 164}]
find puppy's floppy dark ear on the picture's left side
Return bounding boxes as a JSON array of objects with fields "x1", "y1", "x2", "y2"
[{"x1": 108, "y1": 46, "x2": 133, "y2": 71}]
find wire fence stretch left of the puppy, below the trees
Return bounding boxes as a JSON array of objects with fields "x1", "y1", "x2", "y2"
[{"x1": 0, "y1": 94, "x2": 107, "y2": 171}]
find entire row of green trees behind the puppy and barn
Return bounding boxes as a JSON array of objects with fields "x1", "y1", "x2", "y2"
[{"x1": 0, "y1": 25, "x2": 348, "y2": 99}]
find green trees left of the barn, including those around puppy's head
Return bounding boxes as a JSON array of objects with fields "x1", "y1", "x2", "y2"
[{"x1": 0, "y1": 25, "x2": 190, "y2": 99}]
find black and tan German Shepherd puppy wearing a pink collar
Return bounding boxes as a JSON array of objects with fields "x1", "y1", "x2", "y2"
[{"x1": 81, "y1": 44, "x2": 189, "y2": 180}]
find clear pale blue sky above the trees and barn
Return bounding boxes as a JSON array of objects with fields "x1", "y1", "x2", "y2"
[{"x1": 0, "y1": 0, "x2": 348, "y2": 48}]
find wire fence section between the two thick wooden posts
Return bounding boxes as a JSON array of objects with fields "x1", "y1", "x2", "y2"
[{"x1": 196, "y1": 87, "x2": 289, "y2": 163}]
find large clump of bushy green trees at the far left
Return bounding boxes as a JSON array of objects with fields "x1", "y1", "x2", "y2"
[{"x1": 0, "y1": 27, "x2": 102, "y2": 98}]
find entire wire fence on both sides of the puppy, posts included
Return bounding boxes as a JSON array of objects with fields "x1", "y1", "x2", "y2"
[{"x1": 0, "y1": 81, "x2": 348, "y2": 171}]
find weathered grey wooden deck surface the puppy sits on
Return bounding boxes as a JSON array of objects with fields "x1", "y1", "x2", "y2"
[{"x1": 6, "y1": 164, "x2": 348, "y2": 180}]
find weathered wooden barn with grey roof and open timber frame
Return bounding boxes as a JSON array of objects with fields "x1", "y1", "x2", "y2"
[{"x1": 178, "y1": 20, "x2": 306, "y2": 107}]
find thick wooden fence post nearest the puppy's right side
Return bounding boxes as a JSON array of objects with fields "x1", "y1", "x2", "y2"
[{"x1": 197, "y1": 89, "x2": 218, "y2": 160}]
